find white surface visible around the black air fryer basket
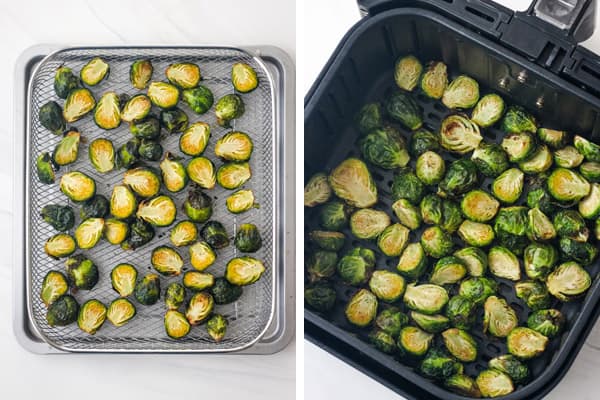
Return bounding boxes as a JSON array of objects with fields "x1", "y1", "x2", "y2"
[{"x1": 298, "y1": 0, "x2": 600, "y2": 400}]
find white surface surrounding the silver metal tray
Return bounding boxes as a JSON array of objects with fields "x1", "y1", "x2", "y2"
[{"x1": 0, "y1": 0, "x2": 295, "y2": 400}]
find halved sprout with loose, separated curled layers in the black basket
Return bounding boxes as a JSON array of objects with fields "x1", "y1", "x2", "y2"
[{"x1": 440, "y1": 114, "x2": 483, "y2": 154}]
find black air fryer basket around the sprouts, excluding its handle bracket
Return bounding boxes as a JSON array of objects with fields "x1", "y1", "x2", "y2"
[{"x1": 305, "y1": 0, "x2": 600, "y2": 400}]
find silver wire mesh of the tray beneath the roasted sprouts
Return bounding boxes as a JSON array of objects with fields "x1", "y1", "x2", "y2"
[{"x1": 26, "y1": 48, "x2": 277, "y2": 352}]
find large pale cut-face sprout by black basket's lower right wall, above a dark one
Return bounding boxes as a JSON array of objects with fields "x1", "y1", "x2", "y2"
[{"x1": 546, "y1": 261, "x2": 592, "y2": 301}]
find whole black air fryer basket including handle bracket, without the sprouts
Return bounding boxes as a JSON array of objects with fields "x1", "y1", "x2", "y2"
[{"x1": 304, "y1": 0, "x2": 600, "y2": 400}]
